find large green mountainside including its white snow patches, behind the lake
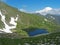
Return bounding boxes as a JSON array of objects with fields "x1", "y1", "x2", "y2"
[{"x1": 0, "y1": 2, "x2": 60, "y2": 36}]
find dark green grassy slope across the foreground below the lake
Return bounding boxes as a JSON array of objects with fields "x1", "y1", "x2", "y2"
[{"x1": 0, "y1": 32, "x2": 60, "y2": 45}]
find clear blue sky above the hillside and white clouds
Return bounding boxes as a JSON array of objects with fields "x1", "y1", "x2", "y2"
[{"x1": 3, "y1": 0, "x2": 60, "y2": 12}]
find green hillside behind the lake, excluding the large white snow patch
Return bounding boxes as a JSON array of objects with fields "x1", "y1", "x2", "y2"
[{"x1": 0, "y1": 2, "x2": 60, "y2": 36}]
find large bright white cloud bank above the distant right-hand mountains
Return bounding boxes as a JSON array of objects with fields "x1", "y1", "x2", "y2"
[{"x1": 35, "y1": 7, "x2": 60, "y2": 15}]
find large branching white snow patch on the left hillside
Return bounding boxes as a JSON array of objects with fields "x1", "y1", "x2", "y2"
[{"x1": 0, "y1": 11, "x2": 18, "y2": 33}]
